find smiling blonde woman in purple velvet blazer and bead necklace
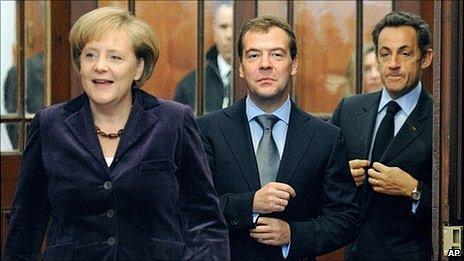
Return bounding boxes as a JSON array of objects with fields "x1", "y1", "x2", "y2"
[{"x1": 4, "y1": 7, "x2": 229, "y2": 260}]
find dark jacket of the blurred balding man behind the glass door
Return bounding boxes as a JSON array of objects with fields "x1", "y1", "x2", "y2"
[{"x1": 174, "y1": 46, "x2": 224, "y2": 112}]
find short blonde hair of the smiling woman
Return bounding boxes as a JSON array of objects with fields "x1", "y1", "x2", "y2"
[{"x1": 69, "y1": 7, "x2": 159, "y2": 87}]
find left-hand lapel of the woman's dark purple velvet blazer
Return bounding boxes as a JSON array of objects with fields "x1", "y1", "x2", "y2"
[{"x1": 64, "y1": 94, "x2": 108, "y2": 169}]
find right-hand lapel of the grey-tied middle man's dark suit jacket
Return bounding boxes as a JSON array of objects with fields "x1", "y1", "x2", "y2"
[{"x1": 276, "y1": 102, "x2": 315, "y2": 183}]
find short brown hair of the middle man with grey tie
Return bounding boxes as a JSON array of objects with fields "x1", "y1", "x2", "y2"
[{"x1": 237, "y1": 16, "x2": 297, "y2": 61}]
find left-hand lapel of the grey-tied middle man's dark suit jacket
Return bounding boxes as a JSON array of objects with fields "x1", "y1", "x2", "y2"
[{"x1": 219, "y1": 99, "x2": 261, "y2": 190}]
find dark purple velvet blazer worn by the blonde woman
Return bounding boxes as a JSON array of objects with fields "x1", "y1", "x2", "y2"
[{"x1": 5, "y1": 89, "x2": 229, "y2": 260}]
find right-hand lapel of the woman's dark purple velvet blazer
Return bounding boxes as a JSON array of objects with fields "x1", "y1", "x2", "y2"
[{"x1": 115, "y1": 89, "x2": 159, "y2": 158}]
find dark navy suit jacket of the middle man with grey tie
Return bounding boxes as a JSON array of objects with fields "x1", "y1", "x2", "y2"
[{"x1": 198, "y1": 99, "x2": 358, "y2": 260}]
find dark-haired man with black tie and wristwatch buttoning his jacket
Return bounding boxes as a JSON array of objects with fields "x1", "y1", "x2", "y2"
[{"x1": 332, "y1": 12, "x2": 433, "y2": 260}]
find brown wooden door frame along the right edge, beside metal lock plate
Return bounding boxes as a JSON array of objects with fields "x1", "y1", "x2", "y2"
[{"x1": 432, "y1": 1, "x2": 464, "y2": 260}]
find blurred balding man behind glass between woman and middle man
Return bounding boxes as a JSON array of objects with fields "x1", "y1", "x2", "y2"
[{"x1": 174, "y1": 1, "x2": 233, "y2": 112}]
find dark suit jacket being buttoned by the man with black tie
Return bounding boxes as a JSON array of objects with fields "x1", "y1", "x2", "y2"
[{"x1": 332, "y1": 89, "x2": 432, "y2": 260}]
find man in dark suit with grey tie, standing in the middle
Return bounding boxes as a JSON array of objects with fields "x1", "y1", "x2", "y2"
[{"x1": 198, "y1": 16, "x2": 358, "y2": 260}]
